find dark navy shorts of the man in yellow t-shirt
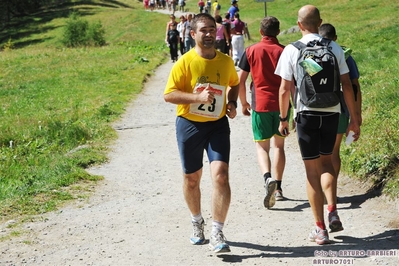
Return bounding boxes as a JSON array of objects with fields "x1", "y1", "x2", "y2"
[{"x1": 176, "y1": 116, "x2": 230, "y2": 174}]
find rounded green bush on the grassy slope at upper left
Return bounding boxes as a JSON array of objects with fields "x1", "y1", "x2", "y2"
[{"x1": 62, "y1": 12, "x2": 105, "y2": 47}]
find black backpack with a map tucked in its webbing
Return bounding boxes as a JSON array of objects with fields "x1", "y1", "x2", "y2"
[{"x1": 292, "y1": 38, "x2": 341, "y2": 108}]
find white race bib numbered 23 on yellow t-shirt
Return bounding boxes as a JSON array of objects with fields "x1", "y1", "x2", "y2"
[{"x1": 190, "y1": 83, "x2": 226, "y2": 118}]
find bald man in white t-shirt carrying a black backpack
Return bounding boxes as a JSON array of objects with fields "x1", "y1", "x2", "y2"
[{"x1": 275, "y1": 5, "x2": 360, "y2": 245}]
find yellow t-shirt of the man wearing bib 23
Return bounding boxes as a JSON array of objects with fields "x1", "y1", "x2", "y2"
[{"x1": 164, "y1": 49, "x2": 240, "y2": 122}]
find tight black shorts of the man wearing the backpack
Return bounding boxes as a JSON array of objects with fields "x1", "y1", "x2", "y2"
[{"x1": 295, "y1": 113, "x2": 339, "y2": 160}]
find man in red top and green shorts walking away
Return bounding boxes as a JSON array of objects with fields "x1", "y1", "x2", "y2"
[{"x1": 238, "y1": 17, "x2": 285, "y2": 209}]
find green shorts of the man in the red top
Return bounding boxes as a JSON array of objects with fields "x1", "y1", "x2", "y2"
[{"x1": 252, "y1": 110, "x2": 290, "y2": 141}]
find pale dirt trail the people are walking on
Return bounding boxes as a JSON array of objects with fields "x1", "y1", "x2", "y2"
[{"x1": 0, "y1": 57, "x2": 399, "y2": 266}]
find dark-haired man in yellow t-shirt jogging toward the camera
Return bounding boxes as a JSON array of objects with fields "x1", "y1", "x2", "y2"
[{"x1": 164, "y1": 13, "x2": 239, "y2": 253}]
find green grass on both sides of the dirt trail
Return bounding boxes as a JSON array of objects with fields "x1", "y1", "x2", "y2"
[{"x1": 0, "y1": 0, "x2": 399, "y2": 220}]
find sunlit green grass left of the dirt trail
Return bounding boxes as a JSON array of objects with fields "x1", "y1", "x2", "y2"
[{"x1": 0, "y1": 0, "x2": 167, "y2": 219}]
